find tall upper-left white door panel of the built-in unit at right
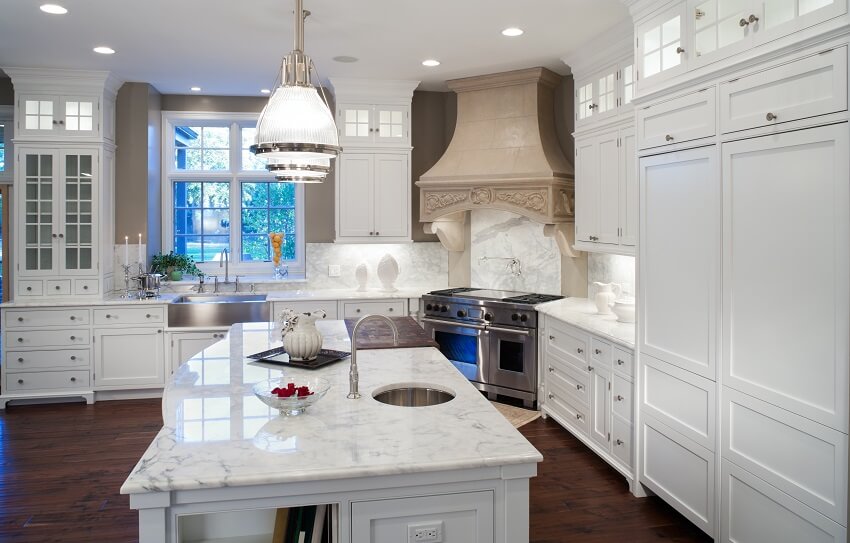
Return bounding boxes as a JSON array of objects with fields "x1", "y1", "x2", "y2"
[{"x1": 638, "y1": 147, "x2": 720, "y2": 380}]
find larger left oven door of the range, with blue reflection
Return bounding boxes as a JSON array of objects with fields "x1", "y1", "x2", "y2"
[{"x1": 422, "y1": 318, "x2": 490, "y2": 383}]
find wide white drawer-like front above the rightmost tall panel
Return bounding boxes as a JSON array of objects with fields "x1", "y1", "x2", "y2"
[{"x1": 720, "y1": 47, "x2": 847, "y2": 133}]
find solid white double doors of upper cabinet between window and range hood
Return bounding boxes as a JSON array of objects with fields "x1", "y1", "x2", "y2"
[{"x1": 337, "y1": 151, "x2": 411, "y2": 242}]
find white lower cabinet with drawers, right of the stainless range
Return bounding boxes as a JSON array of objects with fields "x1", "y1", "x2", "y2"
[{"x1": 539, "y1": 316, "x2": 635, "y2": 482}]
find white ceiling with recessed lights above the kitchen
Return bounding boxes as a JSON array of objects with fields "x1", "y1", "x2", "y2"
[{"x1": 0, "y1": 0, "x2": 628, "y2": 95}]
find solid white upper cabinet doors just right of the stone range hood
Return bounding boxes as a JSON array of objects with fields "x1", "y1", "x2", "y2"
[{"x1": 575, "y1": 126, "x2": 638, "y2": 254}]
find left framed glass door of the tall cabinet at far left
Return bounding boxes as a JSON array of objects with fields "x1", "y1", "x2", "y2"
[{"x1": 19, "y1": 151, "x2": 58, "y2": 275}]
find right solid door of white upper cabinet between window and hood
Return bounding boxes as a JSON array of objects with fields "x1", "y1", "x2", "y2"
[{"x1": 374, "y1": 154, "x2": 410, "y2": 237}]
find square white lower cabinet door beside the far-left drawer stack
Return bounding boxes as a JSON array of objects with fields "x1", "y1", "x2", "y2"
[{"x1": 94, "y1": 327, "x2": 165, "y2": 390}]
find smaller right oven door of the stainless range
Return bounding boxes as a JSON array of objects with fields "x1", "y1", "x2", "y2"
[{"x1": 487, "y1": 326, "x2": 537, "y2": 392}]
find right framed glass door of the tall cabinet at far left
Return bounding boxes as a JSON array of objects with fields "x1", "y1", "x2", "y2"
[{"x1": 59, "y1": 152, "x2": 97, "y2": 274}]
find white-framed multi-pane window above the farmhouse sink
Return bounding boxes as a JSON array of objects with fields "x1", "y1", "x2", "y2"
[{"x1": 163, "y1": 112, "x2": 304, "y2": 276}]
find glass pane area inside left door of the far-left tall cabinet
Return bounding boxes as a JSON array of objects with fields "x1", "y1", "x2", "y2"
[{"x1": 24, "y1": 154, "x2": 54, "y2": 271}]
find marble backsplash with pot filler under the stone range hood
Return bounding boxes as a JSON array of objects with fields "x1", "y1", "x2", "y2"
[{"x1": 470, "y1": 209, "x2": 561, "y2": 294}]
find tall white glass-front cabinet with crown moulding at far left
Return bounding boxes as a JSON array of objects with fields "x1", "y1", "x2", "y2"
[{"x1": 4, "y1": 68, "x2": 120, "y2": 301}]
